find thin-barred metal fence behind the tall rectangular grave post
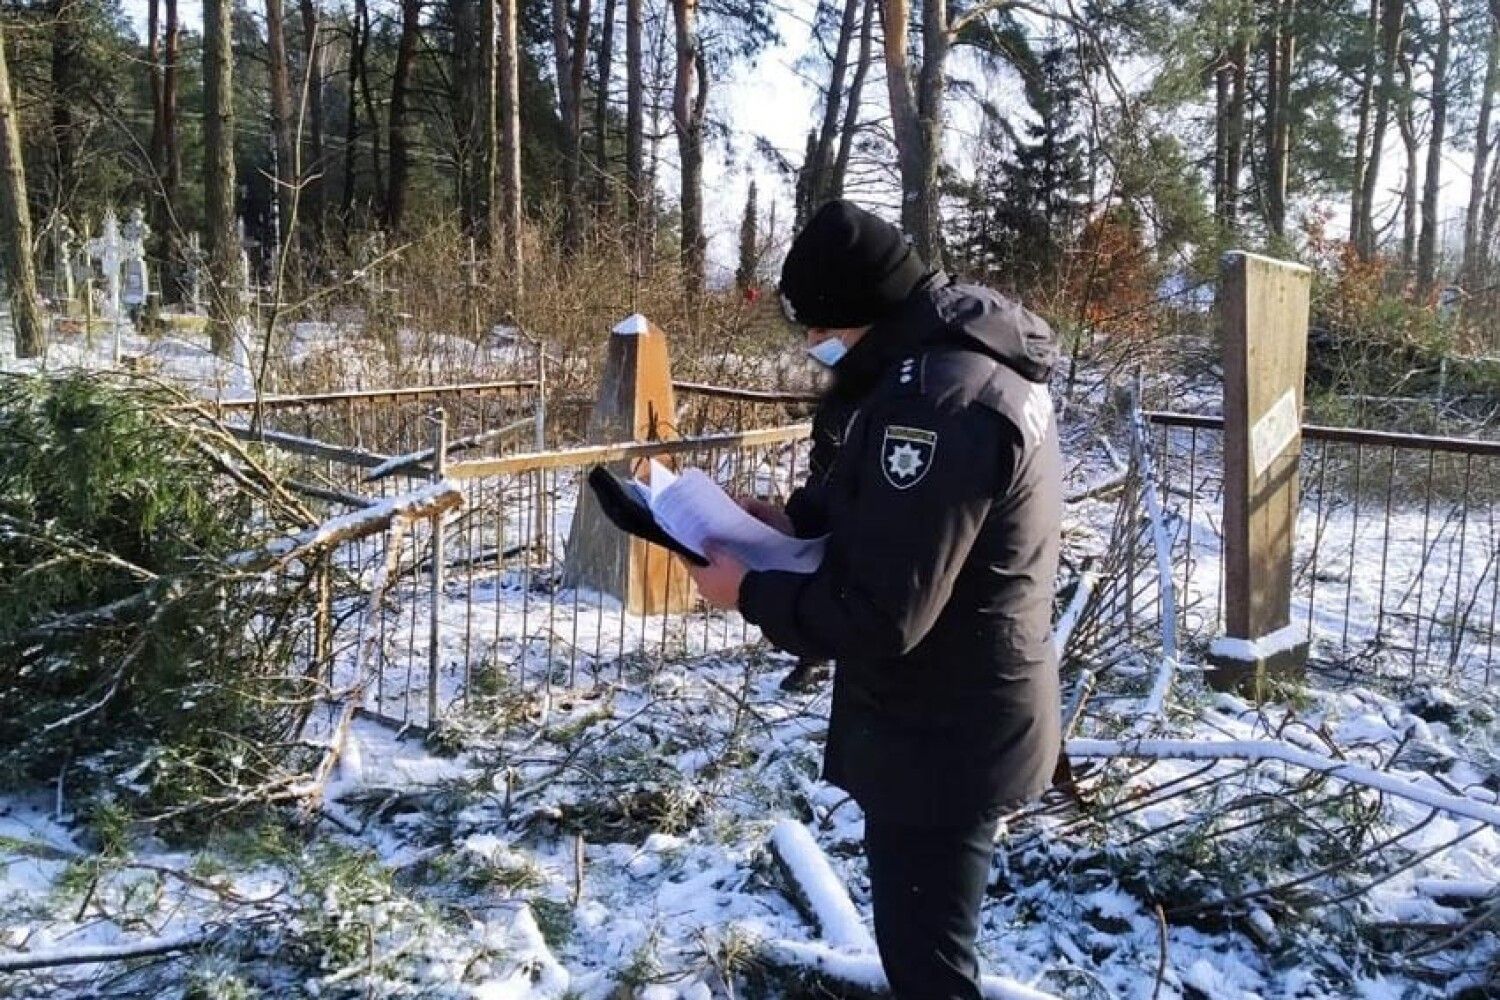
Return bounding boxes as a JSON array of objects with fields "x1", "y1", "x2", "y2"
[{"x1": 1146, "y1": 412, "x2": 1500, "y2": 684}]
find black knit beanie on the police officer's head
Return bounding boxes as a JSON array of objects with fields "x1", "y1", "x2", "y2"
[{"x1": 782, "y1": 201, "x2": 927, "y2": 328}]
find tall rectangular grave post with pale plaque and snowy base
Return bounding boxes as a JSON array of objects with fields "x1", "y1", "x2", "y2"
[{"x1": 1209, "y1": 250, "x2": 1313, "y2": 694}]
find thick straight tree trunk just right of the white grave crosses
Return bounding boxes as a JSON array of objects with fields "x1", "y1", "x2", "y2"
[{"x1": 203, "y1": 0, "x2": 240, "y2": 355}]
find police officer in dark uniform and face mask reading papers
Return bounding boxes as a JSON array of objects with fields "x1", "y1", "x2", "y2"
[{"x1": 693, "y1": 201, "x2": 1062, "y2": 1000}]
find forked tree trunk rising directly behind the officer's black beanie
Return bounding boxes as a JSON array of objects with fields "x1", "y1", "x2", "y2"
[{"x1": 884, "y1": 0, "x2": 950, "y2": 267}]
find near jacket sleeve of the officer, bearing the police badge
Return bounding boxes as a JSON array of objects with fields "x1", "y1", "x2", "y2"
[{"x1": 740, "y1": 397, "x2": 1017, "y2": 660}]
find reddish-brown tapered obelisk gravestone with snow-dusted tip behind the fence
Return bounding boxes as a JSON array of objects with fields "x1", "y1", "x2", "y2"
[{"x1": 564, "y1": 315, "x2": 693, "y2": 615}]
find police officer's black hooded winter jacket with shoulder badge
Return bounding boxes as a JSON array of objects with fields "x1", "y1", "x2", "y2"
[{"x1": 740, "y1": 274, "x2": 1062, "y2": 825}]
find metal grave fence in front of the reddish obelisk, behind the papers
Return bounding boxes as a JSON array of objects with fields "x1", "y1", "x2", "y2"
[{"x1": 327, "y1": 424, "x2": 810, "y2": 726}]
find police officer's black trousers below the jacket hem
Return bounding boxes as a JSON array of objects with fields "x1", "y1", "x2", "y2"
[{"x1": 864, "y1": 816, "x2": 998, "y2": 1000}]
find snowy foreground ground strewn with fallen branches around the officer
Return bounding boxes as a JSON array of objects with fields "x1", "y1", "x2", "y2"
[{"x1": 0, "y1": 334, "x2": 1500, "y2": 1000}]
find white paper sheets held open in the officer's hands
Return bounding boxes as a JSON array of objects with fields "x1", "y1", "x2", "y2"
[{"x1": 651, "y1": 462, "x2": 825, "y2": 573}]
